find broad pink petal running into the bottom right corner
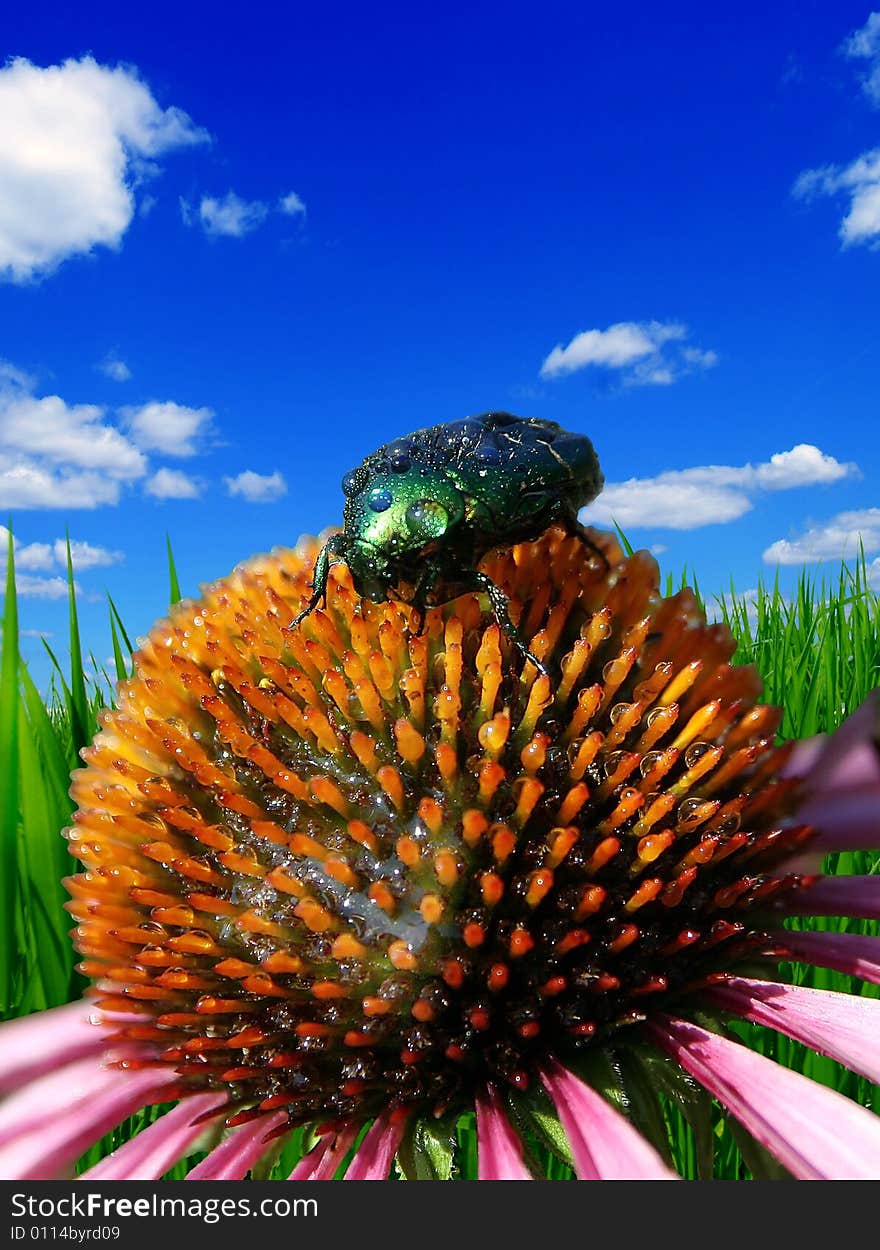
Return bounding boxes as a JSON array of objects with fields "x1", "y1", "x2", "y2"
[{"x1": 646, "y1": 1018, "x2": 880, "y2": 1180}]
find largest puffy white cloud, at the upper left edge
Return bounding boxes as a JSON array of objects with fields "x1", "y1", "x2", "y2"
[{"x1": 0, "y1": 56, "x2": 209, "y2": 283}]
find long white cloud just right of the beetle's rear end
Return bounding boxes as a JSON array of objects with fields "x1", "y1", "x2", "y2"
[{"x1": 580, "y1": 443, "x2": 858, "y2": 530}]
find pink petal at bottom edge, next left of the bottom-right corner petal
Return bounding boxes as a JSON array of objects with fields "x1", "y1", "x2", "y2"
[{"x1": 541, "y1": 1061, "x2": 679, "y2": 1180}]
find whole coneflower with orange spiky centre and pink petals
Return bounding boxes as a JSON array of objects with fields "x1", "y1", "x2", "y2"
[{"x1": 0, "y1": 530, "x2": 880, "y2": 1179}]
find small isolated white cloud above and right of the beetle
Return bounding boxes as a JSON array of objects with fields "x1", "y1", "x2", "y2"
[{"x1": 541, "y1": 321, "x2": 718, "y2": 386}]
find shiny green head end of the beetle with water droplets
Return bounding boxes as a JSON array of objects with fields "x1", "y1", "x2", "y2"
[{"x1": 343, "y1": 465, "x2": 464, "y2": 575}]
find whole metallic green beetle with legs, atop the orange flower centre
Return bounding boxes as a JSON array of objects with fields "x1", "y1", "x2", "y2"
[{"x1": 294, "y1": 413, "x2": 604, "y2": 671}]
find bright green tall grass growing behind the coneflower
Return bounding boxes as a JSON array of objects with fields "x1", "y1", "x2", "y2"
[{"x1": 0, "y1": 534, "x2": 880, "y2": 1179}]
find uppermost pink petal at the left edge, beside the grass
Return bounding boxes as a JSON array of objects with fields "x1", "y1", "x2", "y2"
[{"x1": 0, "y1": 1000, "x2": 108, "y2": 1094}]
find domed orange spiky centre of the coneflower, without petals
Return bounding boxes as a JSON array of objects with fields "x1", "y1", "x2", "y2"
[{"x1": 68, "y1": 530, "x2": 809, "y2": 1124}]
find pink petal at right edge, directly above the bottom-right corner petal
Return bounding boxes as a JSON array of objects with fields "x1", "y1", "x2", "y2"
[{"x1": 705, "y1": 976, "x2": 880, "y2": 1081}]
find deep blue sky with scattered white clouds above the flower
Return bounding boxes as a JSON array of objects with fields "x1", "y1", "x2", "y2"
[{"x1": 0, "y1": 0, "x2": 880, "y2": 675}]
